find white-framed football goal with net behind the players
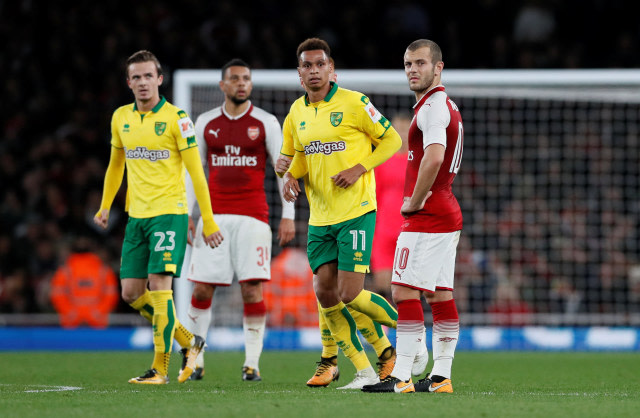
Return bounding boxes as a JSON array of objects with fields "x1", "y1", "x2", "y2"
[{"x1": 173, "y1": 70, "x2": 640, "y2": 326}]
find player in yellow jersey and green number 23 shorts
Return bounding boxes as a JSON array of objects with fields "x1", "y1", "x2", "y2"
[{"x1": 94, "y1": 51, "x2": 223, "y2": 384}]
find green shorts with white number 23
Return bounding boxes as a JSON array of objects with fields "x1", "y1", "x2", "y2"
[{"x1": 120, "y1": 214, "x2": 189, "y2": 279}]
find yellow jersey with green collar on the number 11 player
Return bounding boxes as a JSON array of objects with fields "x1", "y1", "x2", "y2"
[{"x1": 281, "y1": 83, "x2": 402, "y2": 226}]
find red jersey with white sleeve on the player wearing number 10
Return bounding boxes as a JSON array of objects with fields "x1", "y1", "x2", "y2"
[{"x1": 402, "y1": 86, "x2": 463, "y2": 232}]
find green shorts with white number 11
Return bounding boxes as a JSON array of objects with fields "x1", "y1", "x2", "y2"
[{"x1": 307, "y1": 211, "x2": 376, "y2": 273}]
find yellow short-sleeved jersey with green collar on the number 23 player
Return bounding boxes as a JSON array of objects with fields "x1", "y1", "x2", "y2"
[{"x1": 111, "y1": 97, "x2": 197, "y2": 218}]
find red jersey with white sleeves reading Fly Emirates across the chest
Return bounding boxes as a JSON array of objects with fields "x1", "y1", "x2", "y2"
[{"x1": 191, "y1": 105, "x2": 282, "y2": 223}]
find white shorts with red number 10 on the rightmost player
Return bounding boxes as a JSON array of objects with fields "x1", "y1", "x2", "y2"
[{"x1": 391, "y1": 231, "x2": 460, "y2": 293}]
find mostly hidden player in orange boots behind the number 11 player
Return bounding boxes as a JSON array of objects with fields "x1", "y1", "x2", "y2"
[{"x1": 275, "y1": 69, "x2": 396, "y2": 387}]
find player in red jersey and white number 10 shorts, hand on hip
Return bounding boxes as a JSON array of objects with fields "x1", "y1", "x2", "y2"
[{"x1": 362, "y1": 39, "x2": 463, "y2": 393}]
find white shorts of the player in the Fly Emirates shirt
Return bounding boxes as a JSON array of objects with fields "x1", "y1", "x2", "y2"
[{"x1": 188, "y1": 215, "x2": 271, "y2": 286}]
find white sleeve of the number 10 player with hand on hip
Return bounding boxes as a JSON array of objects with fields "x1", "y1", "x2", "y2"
[{"x1": 416, "y1": 91, "x2": 451, "y2": 148}]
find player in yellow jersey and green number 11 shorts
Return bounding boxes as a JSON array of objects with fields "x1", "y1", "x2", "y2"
[{"x1": 284, "y1": 38, "x2": 402, "y2": 389}]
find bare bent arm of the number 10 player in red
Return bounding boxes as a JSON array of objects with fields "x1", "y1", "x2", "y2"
[{"x1": 400, "y1": 144, "x2": 445, "y2": 217}]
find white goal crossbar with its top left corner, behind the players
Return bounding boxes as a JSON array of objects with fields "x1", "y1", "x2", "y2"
[{"x1": 173, "y1": 69, "x2": 640, "y2": 119}]
